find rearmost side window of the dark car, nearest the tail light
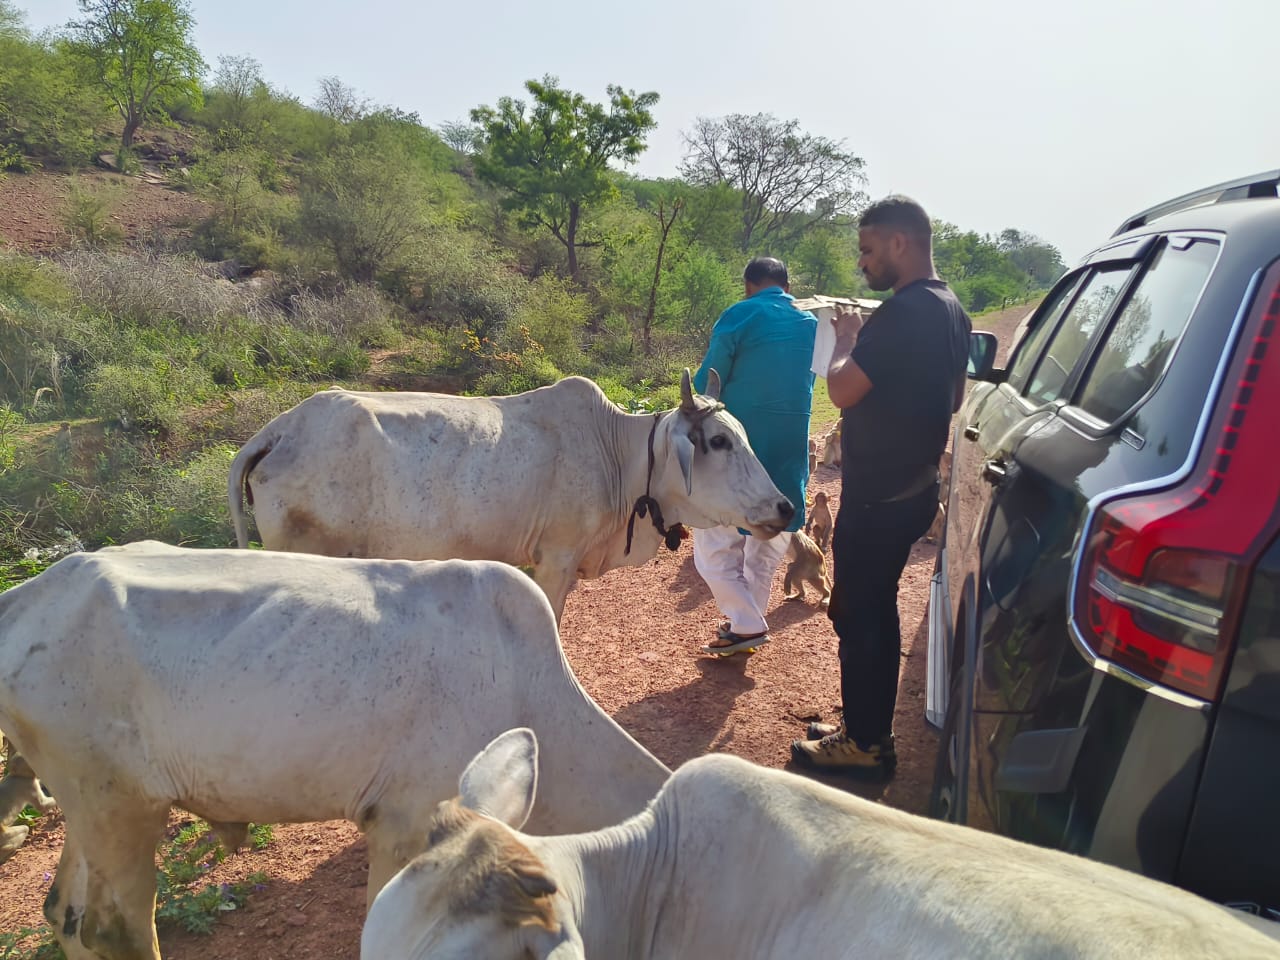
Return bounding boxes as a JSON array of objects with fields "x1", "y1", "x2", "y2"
[{"x1": 1078, "y1": 238, "x2": 1219, "y2": 422}]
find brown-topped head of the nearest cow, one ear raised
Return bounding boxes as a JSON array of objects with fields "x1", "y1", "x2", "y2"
[{"x1": 360, "y1": 728, "x2": 585, "y2": 960}]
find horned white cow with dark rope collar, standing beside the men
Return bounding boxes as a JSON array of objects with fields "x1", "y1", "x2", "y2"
[{"x1": 228, "y1": 370, "x2": 795, "y2": 621}]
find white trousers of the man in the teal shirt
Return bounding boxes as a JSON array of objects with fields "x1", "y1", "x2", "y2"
[{"x1": 694, "y1": 526, "x2": 791, "y2": 636}]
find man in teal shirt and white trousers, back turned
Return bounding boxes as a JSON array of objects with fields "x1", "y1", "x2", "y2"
[{"x1": 694, "y1": 257, "x2": 818, "y2": 654}]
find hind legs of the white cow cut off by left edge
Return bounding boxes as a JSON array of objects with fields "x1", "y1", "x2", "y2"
[{"x1": 45, "y1": 801, "x2": 168, "y2": 960}]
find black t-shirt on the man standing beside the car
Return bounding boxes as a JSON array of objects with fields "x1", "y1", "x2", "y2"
[{"x1": 841, "y1": 280, "x2": 973, "y2": 503}]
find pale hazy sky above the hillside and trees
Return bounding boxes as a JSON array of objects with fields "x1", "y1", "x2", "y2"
[{"x1": 17, "y1": 0, "x2": 1280, "y2": 261}]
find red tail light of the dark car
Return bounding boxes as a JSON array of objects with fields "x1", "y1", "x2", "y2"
[{"x1": 1073, "y1": 268, "x2": 1280, "y2": 700}]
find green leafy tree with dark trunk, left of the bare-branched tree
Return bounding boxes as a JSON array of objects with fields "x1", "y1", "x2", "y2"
[{"x1": 471, "y1": 77, "x2": 658, "y2": 283}]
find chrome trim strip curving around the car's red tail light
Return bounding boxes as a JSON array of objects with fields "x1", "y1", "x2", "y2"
[{"x1": 1066, "y1": 268, "x2": 1270, "y2": 712}]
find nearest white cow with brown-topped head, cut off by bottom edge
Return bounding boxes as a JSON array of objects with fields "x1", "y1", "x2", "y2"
[{"x1": 360, "y1": 730, "x2": 1280, "y2": 960}]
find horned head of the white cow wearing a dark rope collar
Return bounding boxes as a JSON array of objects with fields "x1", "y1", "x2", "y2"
[{"x1": 654, "y1": 370, "x2": 795, "y2": 539}]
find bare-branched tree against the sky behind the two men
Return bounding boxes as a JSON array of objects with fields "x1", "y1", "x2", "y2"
[{"x1": 681, "y1": 114, "x2": 867, "y2": 253}]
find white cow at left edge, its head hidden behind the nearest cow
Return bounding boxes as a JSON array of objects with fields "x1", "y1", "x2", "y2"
[{"x1": 0, "y1": 543, "x2": 669, "y2": 960}]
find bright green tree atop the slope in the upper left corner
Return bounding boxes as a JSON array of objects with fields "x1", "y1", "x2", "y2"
[{"x1": 68, "y1": 0, "x2": 205, "y2": 152}]
